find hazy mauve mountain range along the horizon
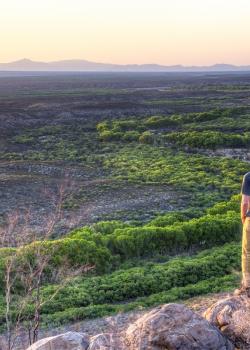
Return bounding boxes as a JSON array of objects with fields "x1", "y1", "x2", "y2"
[{"x1": 0, "y1": 58, "x2": 250, "y2": 72}]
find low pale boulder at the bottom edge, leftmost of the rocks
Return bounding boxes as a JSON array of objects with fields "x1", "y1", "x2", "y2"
[{"x1": 27, "y1": 332, "x2": 89, "y2": 350}]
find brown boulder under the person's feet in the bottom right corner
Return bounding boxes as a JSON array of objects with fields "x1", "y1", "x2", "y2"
[{"x1": 203, "y1": 295, "x2": 250, "y2": 349}]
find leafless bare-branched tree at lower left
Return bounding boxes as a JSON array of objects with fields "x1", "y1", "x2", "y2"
[{"x1": 0, "y1": 178, "x2": 94, "y2": 350}]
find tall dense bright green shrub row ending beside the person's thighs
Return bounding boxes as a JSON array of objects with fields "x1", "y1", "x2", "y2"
[{"x1": 103, "y1": 211, "x2": 241, "y2": 259}]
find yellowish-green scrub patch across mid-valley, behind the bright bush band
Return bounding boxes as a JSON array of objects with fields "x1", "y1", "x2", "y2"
[{"x1": 3, "y1": 107, "x2": 250, "y2": 219}]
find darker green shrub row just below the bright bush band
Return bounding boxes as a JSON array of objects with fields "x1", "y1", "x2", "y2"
[{"x1": 33, "y1": 244, "x2": 241, "y2": 314}]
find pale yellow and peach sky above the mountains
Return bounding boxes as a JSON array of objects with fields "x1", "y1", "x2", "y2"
[{"x1": 0, "y1": 0, "x2": 250, "y2": 65}]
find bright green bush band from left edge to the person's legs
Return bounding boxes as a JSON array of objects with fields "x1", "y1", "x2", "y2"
[{"x1": 0, "y1": 196, "x2": 241, "y2": 288}]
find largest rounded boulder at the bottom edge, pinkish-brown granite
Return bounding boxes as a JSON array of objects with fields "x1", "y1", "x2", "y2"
[{"x1": 126, "y1": 304, "x2": 234, "y2": 350}]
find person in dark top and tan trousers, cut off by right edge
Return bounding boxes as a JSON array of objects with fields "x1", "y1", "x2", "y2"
[{"x1": 235, "y1": 172, "x2": 250, "y2": 297}]
